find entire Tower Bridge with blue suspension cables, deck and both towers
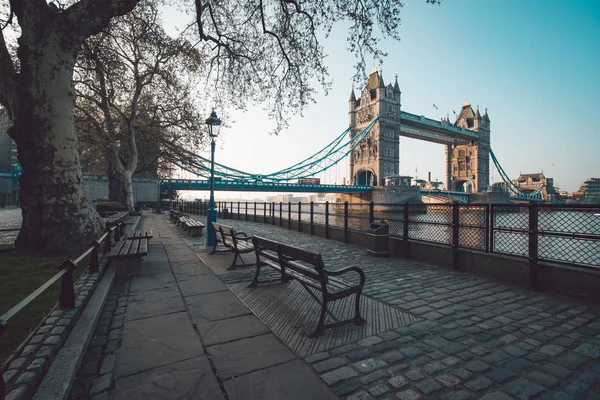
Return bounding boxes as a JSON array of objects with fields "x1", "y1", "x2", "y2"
[{"x1": 161, "y1": 69, "x2": 543, "y2": 202}]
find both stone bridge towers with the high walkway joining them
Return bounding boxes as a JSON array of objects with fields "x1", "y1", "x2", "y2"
[{"x1": 348, "y1": 69, "x2": 491, "y2": 192}]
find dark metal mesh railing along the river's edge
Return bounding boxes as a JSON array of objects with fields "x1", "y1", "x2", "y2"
[{"x1": 172, "y1": 201, "x2": 600, "y2": 278}]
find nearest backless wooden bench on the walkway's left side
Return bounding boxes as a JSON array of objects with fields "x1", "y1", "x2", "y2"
[{"x1": 108, "y1": 231, "x2": 152, "y2": 276}]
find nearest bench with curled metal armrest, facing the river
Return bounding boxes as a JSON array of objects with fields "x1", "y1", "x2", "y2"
[{"x1": 248, "y1": 236, "x2": 365, "y2": 337}]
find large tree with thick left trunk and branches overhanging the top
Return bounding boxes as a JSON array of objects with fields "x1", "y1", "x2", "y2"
[{"x1": 0, "y1": 0, "x2": 440, "y2": 254}]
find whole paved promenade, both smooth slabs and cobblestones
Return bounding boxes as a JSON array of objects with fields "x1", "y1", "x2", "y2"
[{"x1": 71, "y1": 214, "x2": 600, "y2": 400}]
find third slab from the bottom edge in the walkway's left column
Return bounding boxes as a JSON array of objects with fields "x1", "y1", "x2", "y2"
[{"x1": 125, "y1": 287, "x2": 185, "y2": 321}]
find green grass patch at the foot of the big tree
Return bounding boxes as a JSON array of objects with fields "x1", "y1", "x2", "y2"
[{"x1": 0, "y1": 250, "x2": 87, "y2": 364}]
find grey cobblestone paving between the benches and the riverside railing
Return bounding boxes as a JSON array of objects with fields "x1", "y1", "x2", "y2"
[{"x1": 184, "y1": 216, "x2": 600, "y2": 400}]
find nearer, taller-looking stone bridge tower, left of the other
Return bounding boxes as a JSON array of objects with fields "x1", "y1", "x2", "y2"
[{"x1": 348, "y1": 68, "x2": 401, "y2": 186}]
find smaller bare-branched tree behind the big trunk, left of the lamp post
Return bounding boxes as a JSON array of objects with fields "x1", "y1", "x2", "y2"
[{"x1": 75, "y1": 0, "x2": 203, "y2": 210}]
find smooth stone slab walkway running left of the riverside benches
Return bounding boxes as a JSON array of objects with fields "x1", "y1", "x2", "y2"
[{"x1": 71, "y1": 214, "x2": 336, "y2": 400}]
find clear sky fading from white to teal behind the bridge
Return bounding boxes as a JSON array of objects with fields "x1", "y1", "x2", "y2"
[{"x1": 165, "y1": 0, "x2": 600, "y2": 197}]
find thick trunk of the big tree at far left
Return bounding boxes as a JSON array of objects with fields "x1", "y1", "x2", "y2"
[{"x1": 9, "y1": 27, "x2": 103, "y2": 255}]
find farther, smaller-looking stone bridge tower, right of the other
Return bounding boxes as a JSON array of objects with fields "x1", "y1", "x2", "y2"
[{"x1": 446, "y1": 100, "x2": 491, "y2": 192}]
